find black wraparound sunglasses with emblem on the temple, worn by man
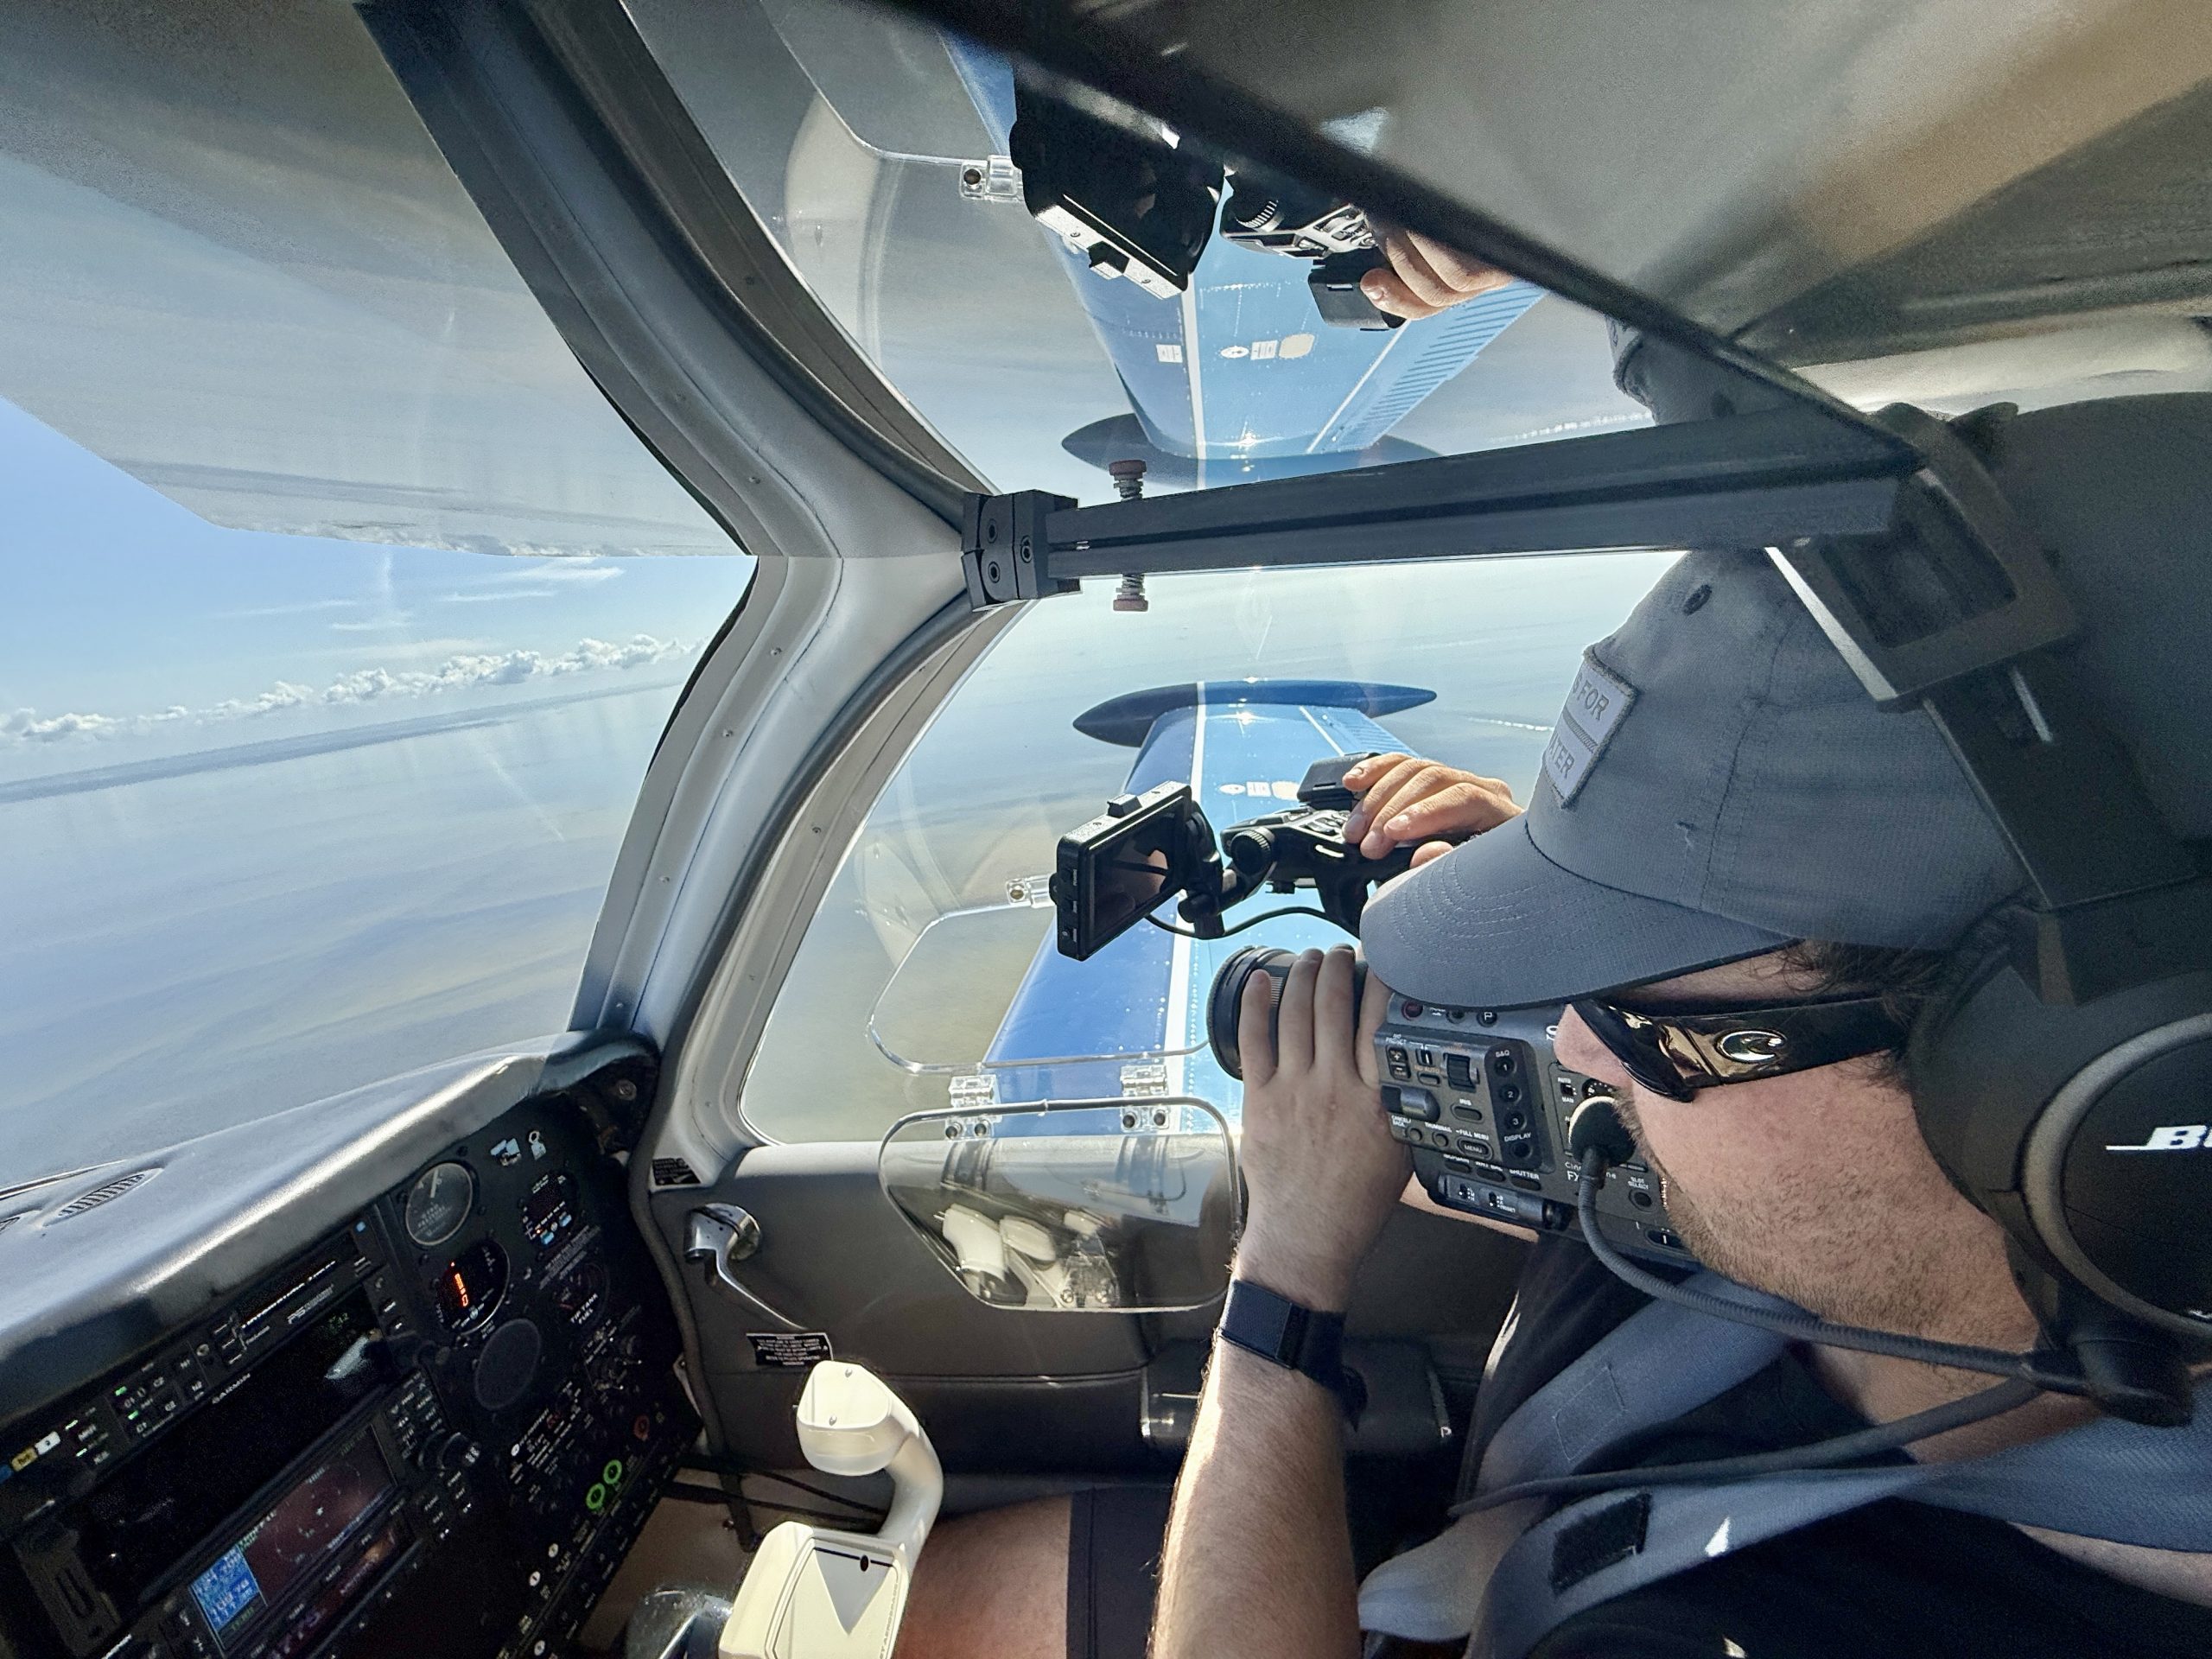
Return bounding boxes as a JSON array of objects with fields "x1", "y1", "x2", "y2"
[{"x1": 1573, "y1": 998, "x2": 1907, "y2": 1099}]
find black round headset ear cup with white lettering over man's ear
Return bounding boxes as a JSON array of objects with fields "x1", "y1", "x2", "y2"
[{"x1": 1907, "y1": 929, "x2": 2212, "y2": 1340}]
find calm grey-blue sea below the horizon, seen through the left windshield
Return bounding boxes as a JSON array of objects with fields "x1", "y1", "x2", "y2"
[{"x1": 0, "y1": 677, "x2": 681, "y2": 1188}]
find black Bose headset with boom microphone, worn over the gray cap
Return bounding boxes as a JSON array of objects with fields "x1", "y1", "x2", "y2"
[{"x1": 1574, "y1": 396, "x2": 2212, "y2": 1433}]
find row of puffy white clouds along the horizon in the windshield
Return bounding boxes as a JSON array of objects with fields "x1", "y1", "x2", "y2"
[{"x1": 0, "y1": 632, "x2": 690, "y2": 746}]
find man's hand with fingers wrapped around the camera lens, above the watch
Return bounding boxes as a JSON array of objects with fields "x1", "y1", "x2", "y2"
[{"x1": 1236, "y1": 944, "x2": 1409, "y2": 1312}]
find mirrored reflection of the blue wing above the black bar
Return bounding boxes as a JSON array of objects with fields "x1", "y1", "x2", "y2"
[{"x1": 944, "y1": 33, "x2": 1541, "y2": 486}]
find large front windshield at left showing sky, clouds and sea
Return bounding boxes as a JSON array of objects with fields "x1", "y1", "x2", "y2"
[{"x1": 0, "y1": 4, "x2": 750, "y2": 1188}]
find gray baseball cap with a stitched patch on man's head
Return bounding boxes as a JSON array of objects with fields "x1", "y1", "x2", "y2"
[{"x1": 1360, "y1": 394, "x2": 2212, "y2": 1007}]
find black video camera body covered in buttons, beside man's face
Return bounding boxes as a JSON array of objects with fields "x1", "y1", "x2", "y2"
[{"x1": 1376, "y1": 998, "x2": 1697, "y2": 1268}]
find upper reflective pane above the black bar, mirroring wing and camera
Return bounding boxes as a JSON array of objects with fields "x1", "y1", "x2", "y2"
[{"x1": 628, "y1": 0, "x2": 1646, "y2": 500}]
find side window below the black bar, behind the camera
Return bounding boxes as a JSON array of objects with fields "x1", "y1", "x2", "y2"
[{"x1": 739, "y1": 553, "x2": 1672, "y2": 1139}]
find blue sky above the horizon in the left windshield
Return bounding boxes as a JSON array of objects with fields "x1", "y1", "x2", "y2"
[{"x1": 0, "y1": 403, "x2": 750, "y2": 752}]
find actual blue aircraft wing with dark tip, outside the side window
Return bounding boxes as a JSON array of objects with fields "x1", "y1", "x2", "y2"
[{"x1": 984, "y1": 679, "x2": 1433, "y2": 1117}]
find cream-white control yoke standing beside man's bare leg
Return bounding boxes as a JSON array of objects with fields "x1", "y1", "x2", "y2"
[{"x1": 716, "y1": 1360, "x2": 944, "y2": 1659}]
